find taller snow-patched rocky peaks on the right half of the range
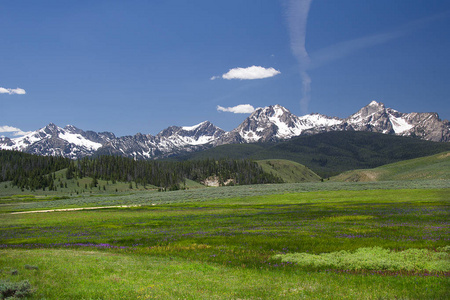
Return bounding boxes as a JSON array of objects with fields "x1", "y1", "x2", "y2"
[{"x1": 215, "y1": 101, "x2": 450, "y2": 145}]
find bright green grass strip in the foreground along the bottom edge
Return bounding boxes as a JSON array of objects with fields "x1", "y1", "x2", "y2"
[{"x1": 1, "y1": 249, "x2": 448, "y2": 299}]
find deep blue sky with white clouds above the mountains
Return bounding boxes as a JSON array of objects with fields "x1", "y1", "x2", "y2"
[{"x1": 0, "y1": 0, "x2": 450, "y2": 137}]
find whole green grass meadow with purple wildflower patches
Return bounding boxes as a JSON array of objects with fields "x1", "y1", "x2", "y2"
[{"x1": 0, "y1": 180, "x2": 450, "y2": 299}]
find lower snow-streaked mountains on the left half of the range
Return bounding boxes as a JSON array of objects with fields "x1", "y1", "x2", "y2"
[{"x1": 0, "y1": 121, "x2": 225, "y2": 159}]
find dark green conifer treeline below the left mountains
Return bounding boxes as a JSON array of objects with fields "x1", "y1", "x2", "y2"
[{"x1": 0, "y1": 150, "x2": 283, "y2": 190}]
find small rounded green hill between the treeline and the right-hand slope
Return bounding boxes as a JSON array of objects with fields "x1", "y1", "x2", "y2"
[{"x1": 257, "y1": 159, "x2": 321, "y2": 183}]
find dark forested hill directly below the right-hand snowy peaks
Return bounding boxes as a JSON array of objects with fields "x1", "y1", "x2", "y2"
[{"x1": 178, "y1": 131, "x2": 450, "y2": 178}]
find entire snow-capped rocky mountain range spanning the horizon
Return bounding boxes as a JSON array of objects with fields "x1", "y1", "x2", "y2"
[{"x1": 0, "y1": 101, "x2": 450, "y2": 159}]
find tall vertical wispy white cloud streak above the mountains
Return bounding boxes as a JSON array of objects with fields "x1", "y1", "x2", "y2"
[{"x1": 286, "y1": 0, "x2": 312, "y2": 113}]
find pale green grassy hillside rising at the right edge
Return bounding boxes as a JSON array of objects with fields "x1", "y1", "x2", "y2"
[{"x1": 332, "y1": 152, "x2": 450, "y2": 182}]
